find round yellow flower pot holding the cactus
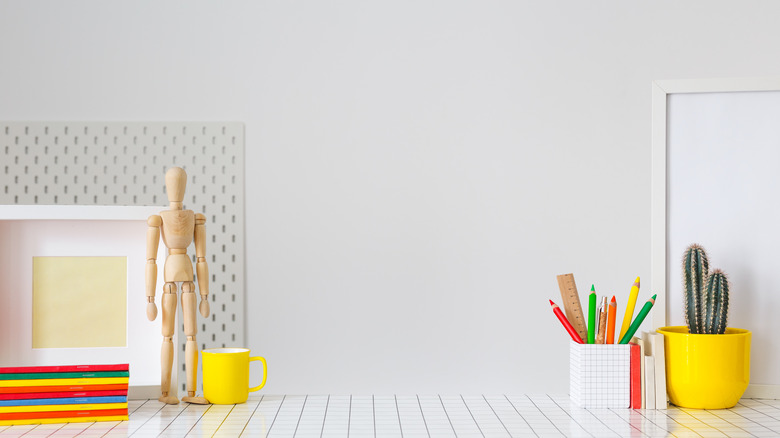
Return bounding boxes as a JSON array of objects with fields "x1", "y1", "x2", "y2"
[{"x1": 657, "y1": 326, "x2": 751, "y2": 409}]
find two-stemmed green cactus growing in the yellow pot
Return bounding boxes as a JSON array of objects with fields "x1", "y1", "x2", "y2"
[{"x1": 683, "y1": 243, "x2": 729, "y2": 334}]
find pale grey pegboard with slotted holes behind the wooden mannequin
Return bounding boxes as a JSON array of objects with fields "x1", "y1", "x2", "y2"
[{"x1": 0, "y1": 122, "x2": 244, "y2": 392}]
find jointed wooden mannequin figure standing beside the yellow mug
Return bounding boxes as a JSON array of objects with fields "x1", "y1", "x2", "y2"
[{"x1": 146, "y1": 167, "x2": 209, "y2": 404}]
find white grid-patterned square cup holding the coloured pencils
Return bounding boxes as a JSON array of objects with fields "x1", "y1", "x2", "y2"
[{"x1": 569, "y1": 342, "x2": 631, "y2": 408}]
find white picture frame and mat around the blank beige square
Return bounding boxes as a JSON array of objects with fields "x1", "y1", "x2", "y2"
[{"x1": 0, "y1": 205, "x2": 172, "y2": 399}]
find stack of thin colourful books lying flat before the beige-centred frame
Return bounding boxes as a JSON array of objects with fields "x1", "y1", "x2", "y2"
[{"x1": 0, "y1": 364, "x2": 130, "y2": 426}]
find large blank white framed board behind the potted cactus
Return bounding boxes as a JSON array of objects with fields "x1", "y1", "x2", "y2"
[{"x1": 651, "y1": 77, "x2": 780, "y2": 398}]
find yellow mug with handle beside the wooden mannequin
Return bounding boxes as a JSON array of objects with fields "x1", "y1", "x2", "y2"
[{"x1": 203, "y1": 348, "x2": 268, "y2": 405}]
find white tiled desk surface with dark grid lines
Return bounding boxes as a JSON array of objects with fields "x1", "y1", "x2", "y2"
[{"x1": 0, "y1": 395, "x2": 780, "y2": 438}]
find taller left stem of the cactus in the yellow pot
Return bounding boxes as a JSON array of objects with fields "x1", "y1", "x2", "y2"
[{"x1": 683, "y1": 244, "x2": 709, "y2": 333}]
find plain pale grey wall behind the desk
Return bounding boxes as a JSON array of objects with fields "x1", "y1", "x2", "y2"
[{"x1": 0, "y1": 0, "x2": 780, "y2": 393}]
